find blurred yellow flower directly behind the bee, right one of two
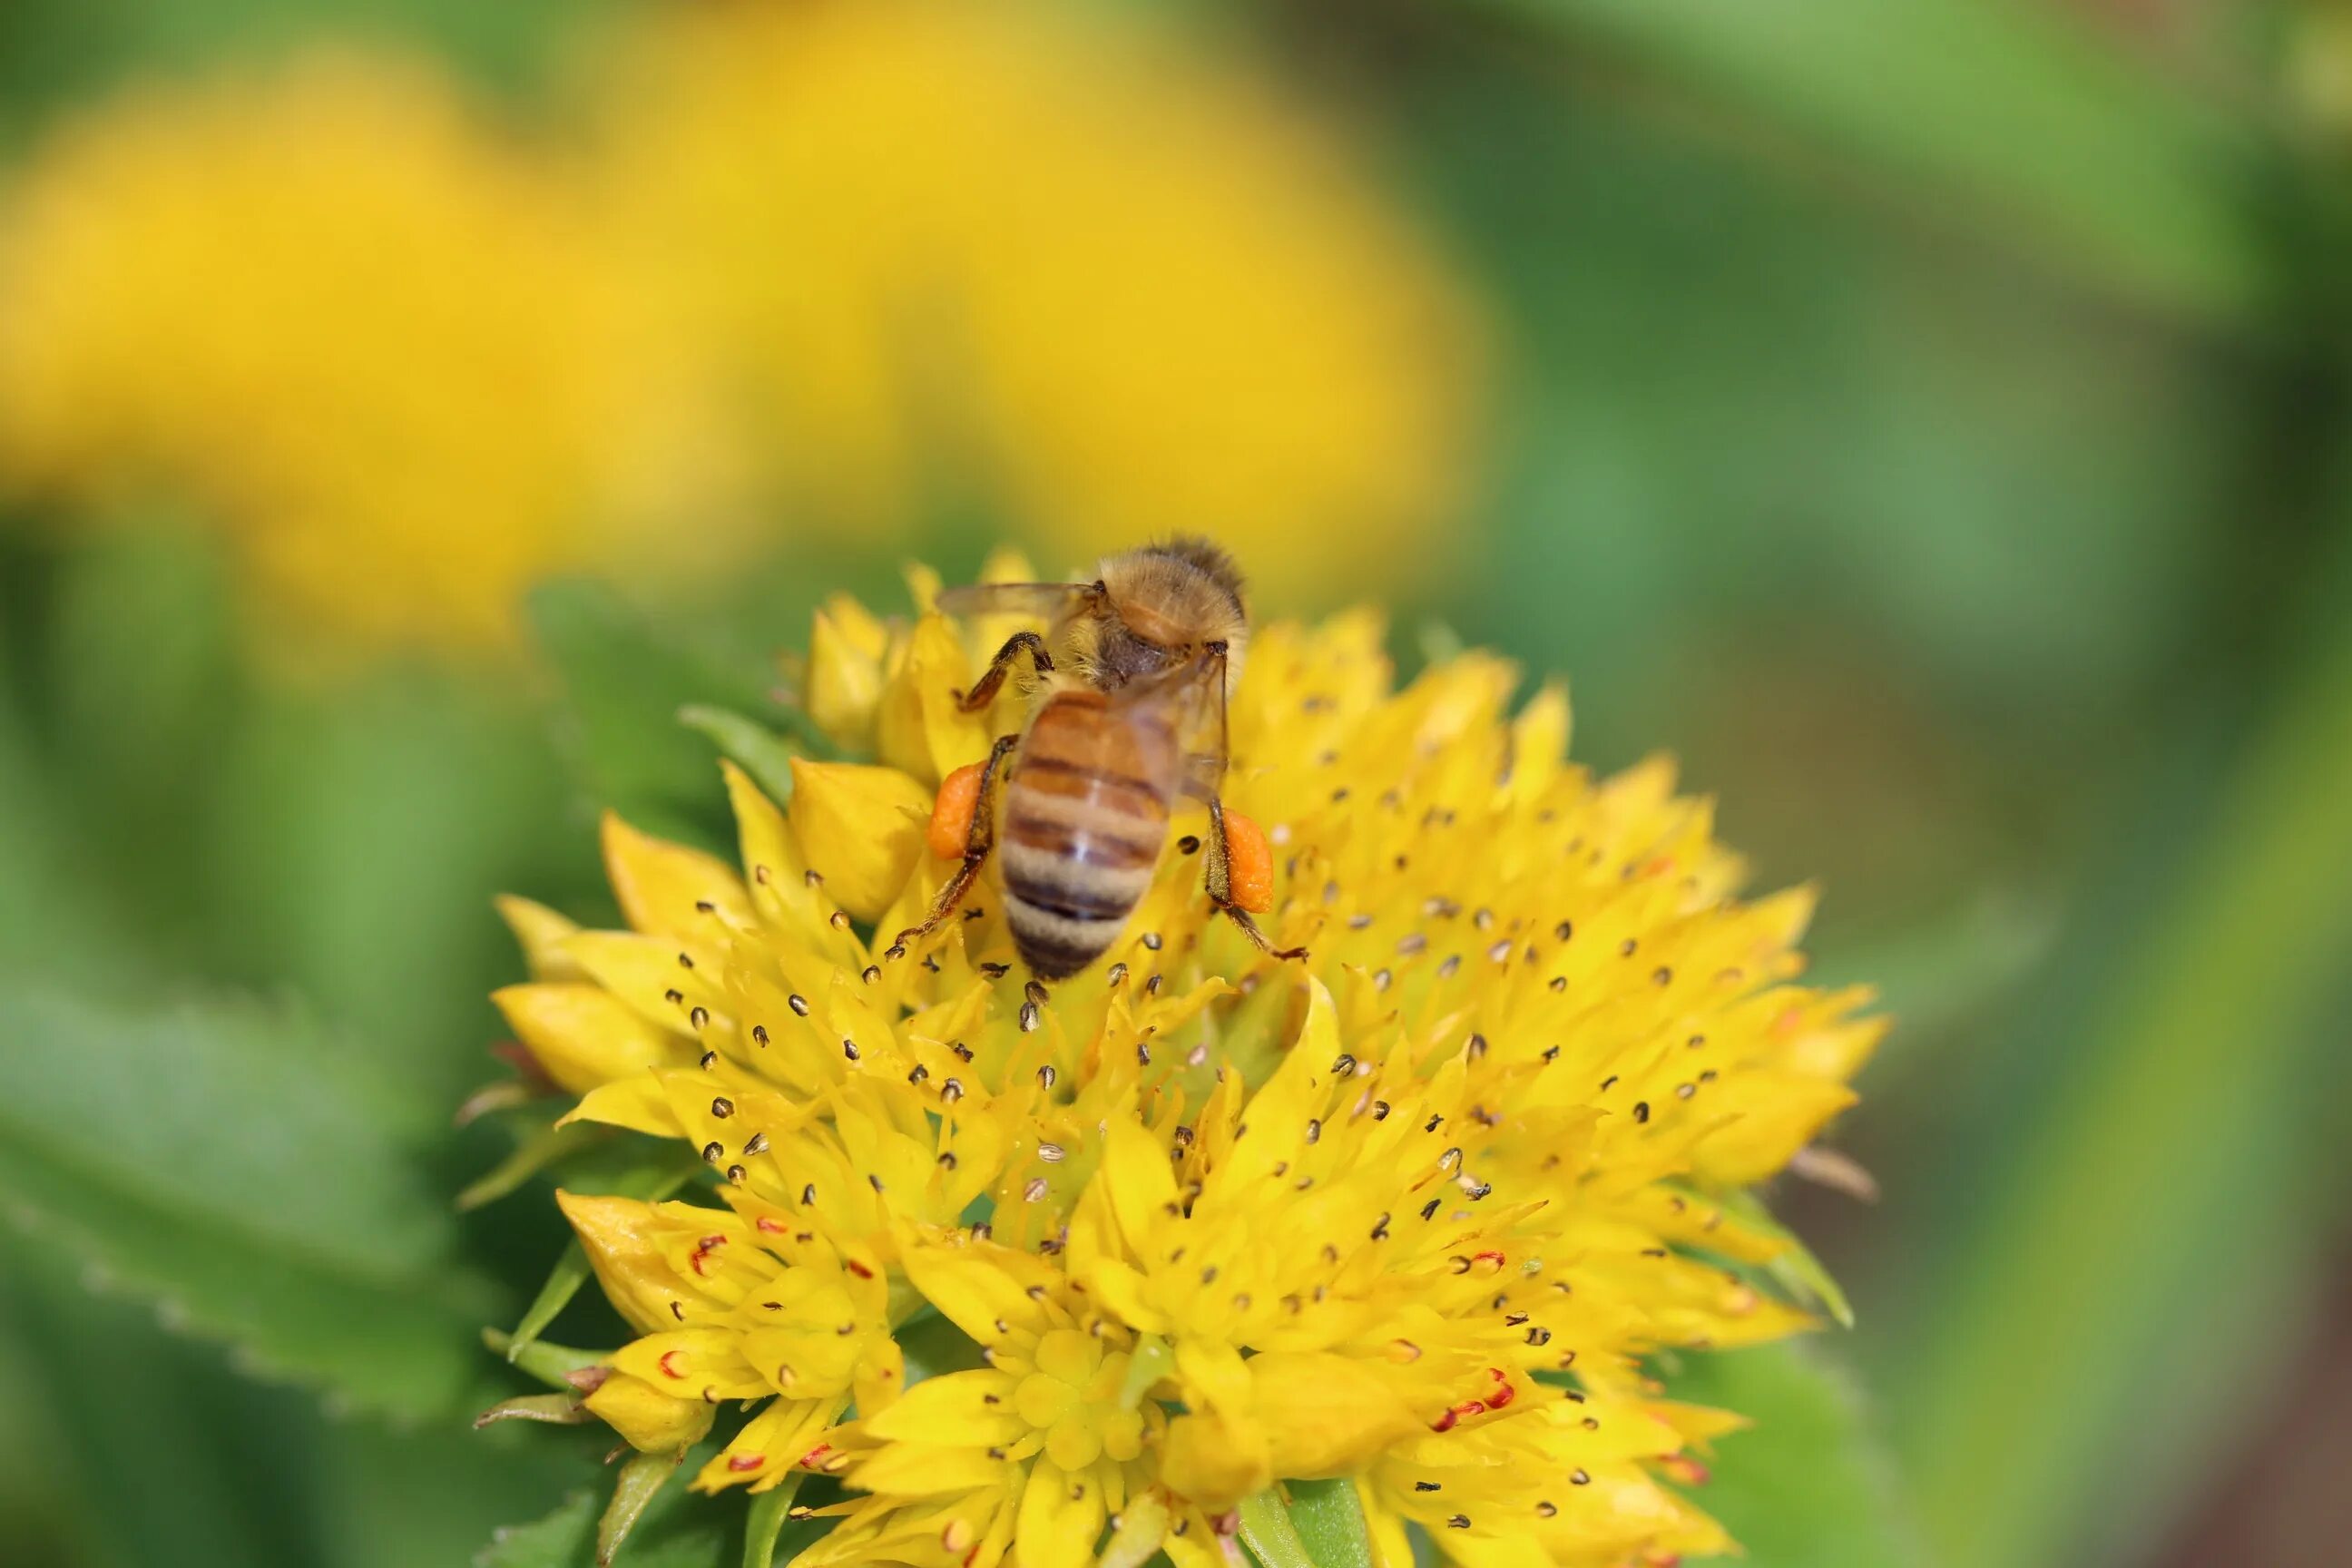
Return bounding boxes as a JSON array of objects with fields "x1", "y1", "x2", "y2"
[{"x1": 583, "y1": 0, "x2": 1477, "y2": 602}]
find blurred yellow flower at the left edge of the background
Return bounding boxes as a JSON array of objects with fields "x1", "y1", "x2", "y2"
[{"x1": 0, "y1": 54, "x2": 672, "y2": 644}]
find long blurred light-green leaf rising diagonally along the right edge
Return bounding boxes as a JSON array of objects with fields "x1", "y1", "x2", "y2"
[{"x1": 1886, "y1": 597, "x2": 2352, "y2": 1568}]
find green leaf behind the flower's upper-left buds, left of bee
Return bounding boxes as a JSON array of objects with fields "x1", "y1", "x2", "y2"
[{"x1": 532, "y1": 583, "x2": 764, "y2": 839}]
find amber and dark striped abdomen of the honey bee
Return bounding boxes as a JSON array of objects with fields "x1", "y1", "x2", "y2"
[{"x1": 997, "y1": 691, "x2": 1183, "y2": 980}]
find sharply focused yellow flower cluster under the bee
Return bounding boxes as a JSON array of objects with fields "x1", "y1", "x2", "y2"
[{"x1": 499, "y1": 564, "x2": 1879, "y2": 1568}]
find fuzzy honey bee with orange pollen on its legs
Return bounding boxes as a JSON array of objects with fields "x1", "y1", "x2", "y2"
[{"x1": 897, "y1": 538, "x2": 1306, "y2": 980}]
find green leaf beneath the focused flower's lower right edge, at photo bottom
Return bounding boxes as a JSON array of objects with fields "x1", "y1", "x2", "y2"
[{"x1": 1668, "y1": 1342, "x2": 1924, "y2": 1568}]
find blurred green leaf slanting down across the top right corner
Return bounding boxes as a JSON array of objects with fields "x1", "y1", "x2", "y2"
[{"x1": 1501, "y1": 0, "x2": 2279, "y2": 319}]
